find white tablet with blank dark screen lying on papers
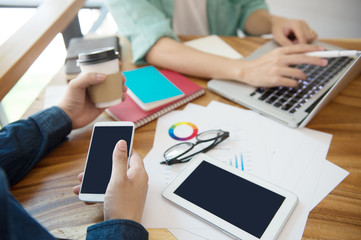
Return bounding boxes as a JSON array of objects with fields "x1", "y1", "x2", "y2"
[{"x1": 162, "y1": 154, "x2": 298, "y2": 239}]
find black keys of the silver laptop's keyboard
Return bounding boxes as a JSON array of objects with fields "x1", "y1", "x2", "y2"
[{"x1": 250, "y1": 57, "x2": 353, "y2": 114}]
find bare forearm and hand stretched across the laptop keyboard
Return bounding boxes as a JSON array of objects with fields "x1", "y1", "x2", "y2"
[{"x1": 146, "y1": 38, "x2": 327, "y2": 87}]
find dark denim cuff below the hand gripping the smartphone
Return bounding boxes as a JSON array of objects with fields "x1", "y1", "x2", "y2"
[{"x1": 86, "y1": 219, "x2": 149, "y2": 240}]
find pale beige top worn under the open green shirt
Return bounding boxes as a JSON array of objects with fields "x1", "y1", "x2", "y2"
[{"x1": 173, "y1": 0, "x2": 209, "y2": 35}]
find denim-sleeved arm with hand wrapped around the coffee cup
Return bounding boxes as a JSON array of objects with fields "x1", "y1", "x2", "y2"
[{"x1": 0, "y1": 73, "x2": 126, "y2": 185}]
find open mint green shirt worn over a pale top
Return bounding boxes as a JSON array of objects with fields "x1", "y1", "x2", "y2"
[{"x1": 106, "y1": 0, "x2": 268, "y2": 64}]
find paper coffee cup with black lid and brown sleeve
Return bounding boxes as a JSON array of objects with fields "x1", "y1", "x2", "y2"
[{"x1": 77, "y1": 48, "x2": 123, "y2": 108}]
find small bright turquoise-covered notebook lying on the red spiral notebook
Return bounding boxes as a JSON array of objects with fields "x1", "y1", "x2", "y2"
[{"x1": 123, "y1": 66, "x2": 184, "y2": 111}]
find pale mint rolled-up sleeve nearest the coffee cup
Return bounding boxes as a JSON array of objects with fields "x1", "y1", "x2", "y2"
[{"x1": 106, "y1": 0, "x2": 179, "y2": 65}]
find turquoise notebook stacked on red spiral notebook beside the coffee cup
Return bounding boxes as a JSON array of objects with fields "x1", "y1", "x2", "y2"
[{"x1": 106, "y1": 66, "x2": 205, "y2": 128}]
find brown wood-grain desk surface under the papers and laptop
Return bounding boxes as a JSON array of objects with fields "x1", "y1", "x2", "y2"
[{"x1": 12, "y1": 37, "x2": 361, "y2": 239}]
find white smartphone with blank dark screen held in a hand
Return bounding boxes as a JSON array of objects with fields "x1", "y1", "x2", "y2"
[{"x1": 79, "y1": 122, "x2": 134, "y2": 202}]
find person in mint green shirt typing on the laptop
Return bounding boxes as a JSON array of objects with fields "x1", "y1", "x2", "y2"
[{"x1": 106, "y1": 0, "x2": 327, "y2": 87}]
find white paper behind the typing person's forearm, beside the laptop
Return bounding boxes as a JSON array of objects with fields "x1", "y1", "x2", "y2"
[{"x1": 184, "y1": 35, "x2": 243, "y2": 59}]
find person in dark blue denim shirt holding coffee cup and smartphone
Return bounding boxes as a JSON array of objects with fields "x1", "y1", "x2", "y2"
[{"x1": 0, "y1": 73, "x2": 148, "y2": 240}]
